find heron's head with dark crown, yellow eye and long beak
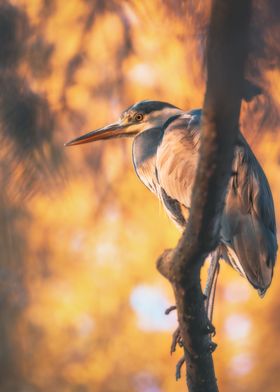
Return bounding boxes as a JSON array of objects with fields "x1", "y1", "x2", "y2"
[{"x1": 65, "y1": 101, "x2": 181, "y2": 146}]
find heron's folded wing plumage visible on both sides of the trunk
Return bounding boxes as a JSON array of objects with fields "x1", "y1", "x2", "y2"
[{"x1": 155, "y1": 113, "x2": 277, "y2": 294}]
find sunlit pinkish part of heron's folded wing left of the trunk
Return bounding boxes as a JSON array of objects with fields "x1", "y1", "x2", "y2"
[{"x1": 156, "y1": 111, "x2": 201, "y2": 227}]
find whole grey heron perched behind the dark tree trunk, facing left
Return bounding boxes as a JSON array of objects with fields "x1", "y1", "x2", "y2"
[{"x1": 66, "y1": 100, "x2": 277, "y2": 320}]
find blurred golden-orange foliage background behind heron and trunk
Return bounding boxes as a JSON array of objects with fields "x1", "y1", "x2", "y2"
[{"x1": 0, "y1": 0, "x2": 280, "y2": 392}]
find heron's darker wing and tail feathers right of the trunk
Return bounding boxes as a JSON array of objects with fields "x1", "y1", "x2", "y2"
[{"x1": 221, "y1": 134, "x2": 277, "y2": 294}]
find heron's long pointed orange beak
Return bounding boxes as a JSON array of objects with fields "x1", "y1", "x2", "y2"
[{"x1": 64, "y1": 123, "x2": 133, "y2": 146}]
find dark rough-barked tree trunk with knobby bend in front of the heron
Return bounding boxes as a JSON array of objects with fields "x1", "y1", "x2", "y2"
[{"x1": 158, "y1": 0, "x2": 251, "y2": 392}]
